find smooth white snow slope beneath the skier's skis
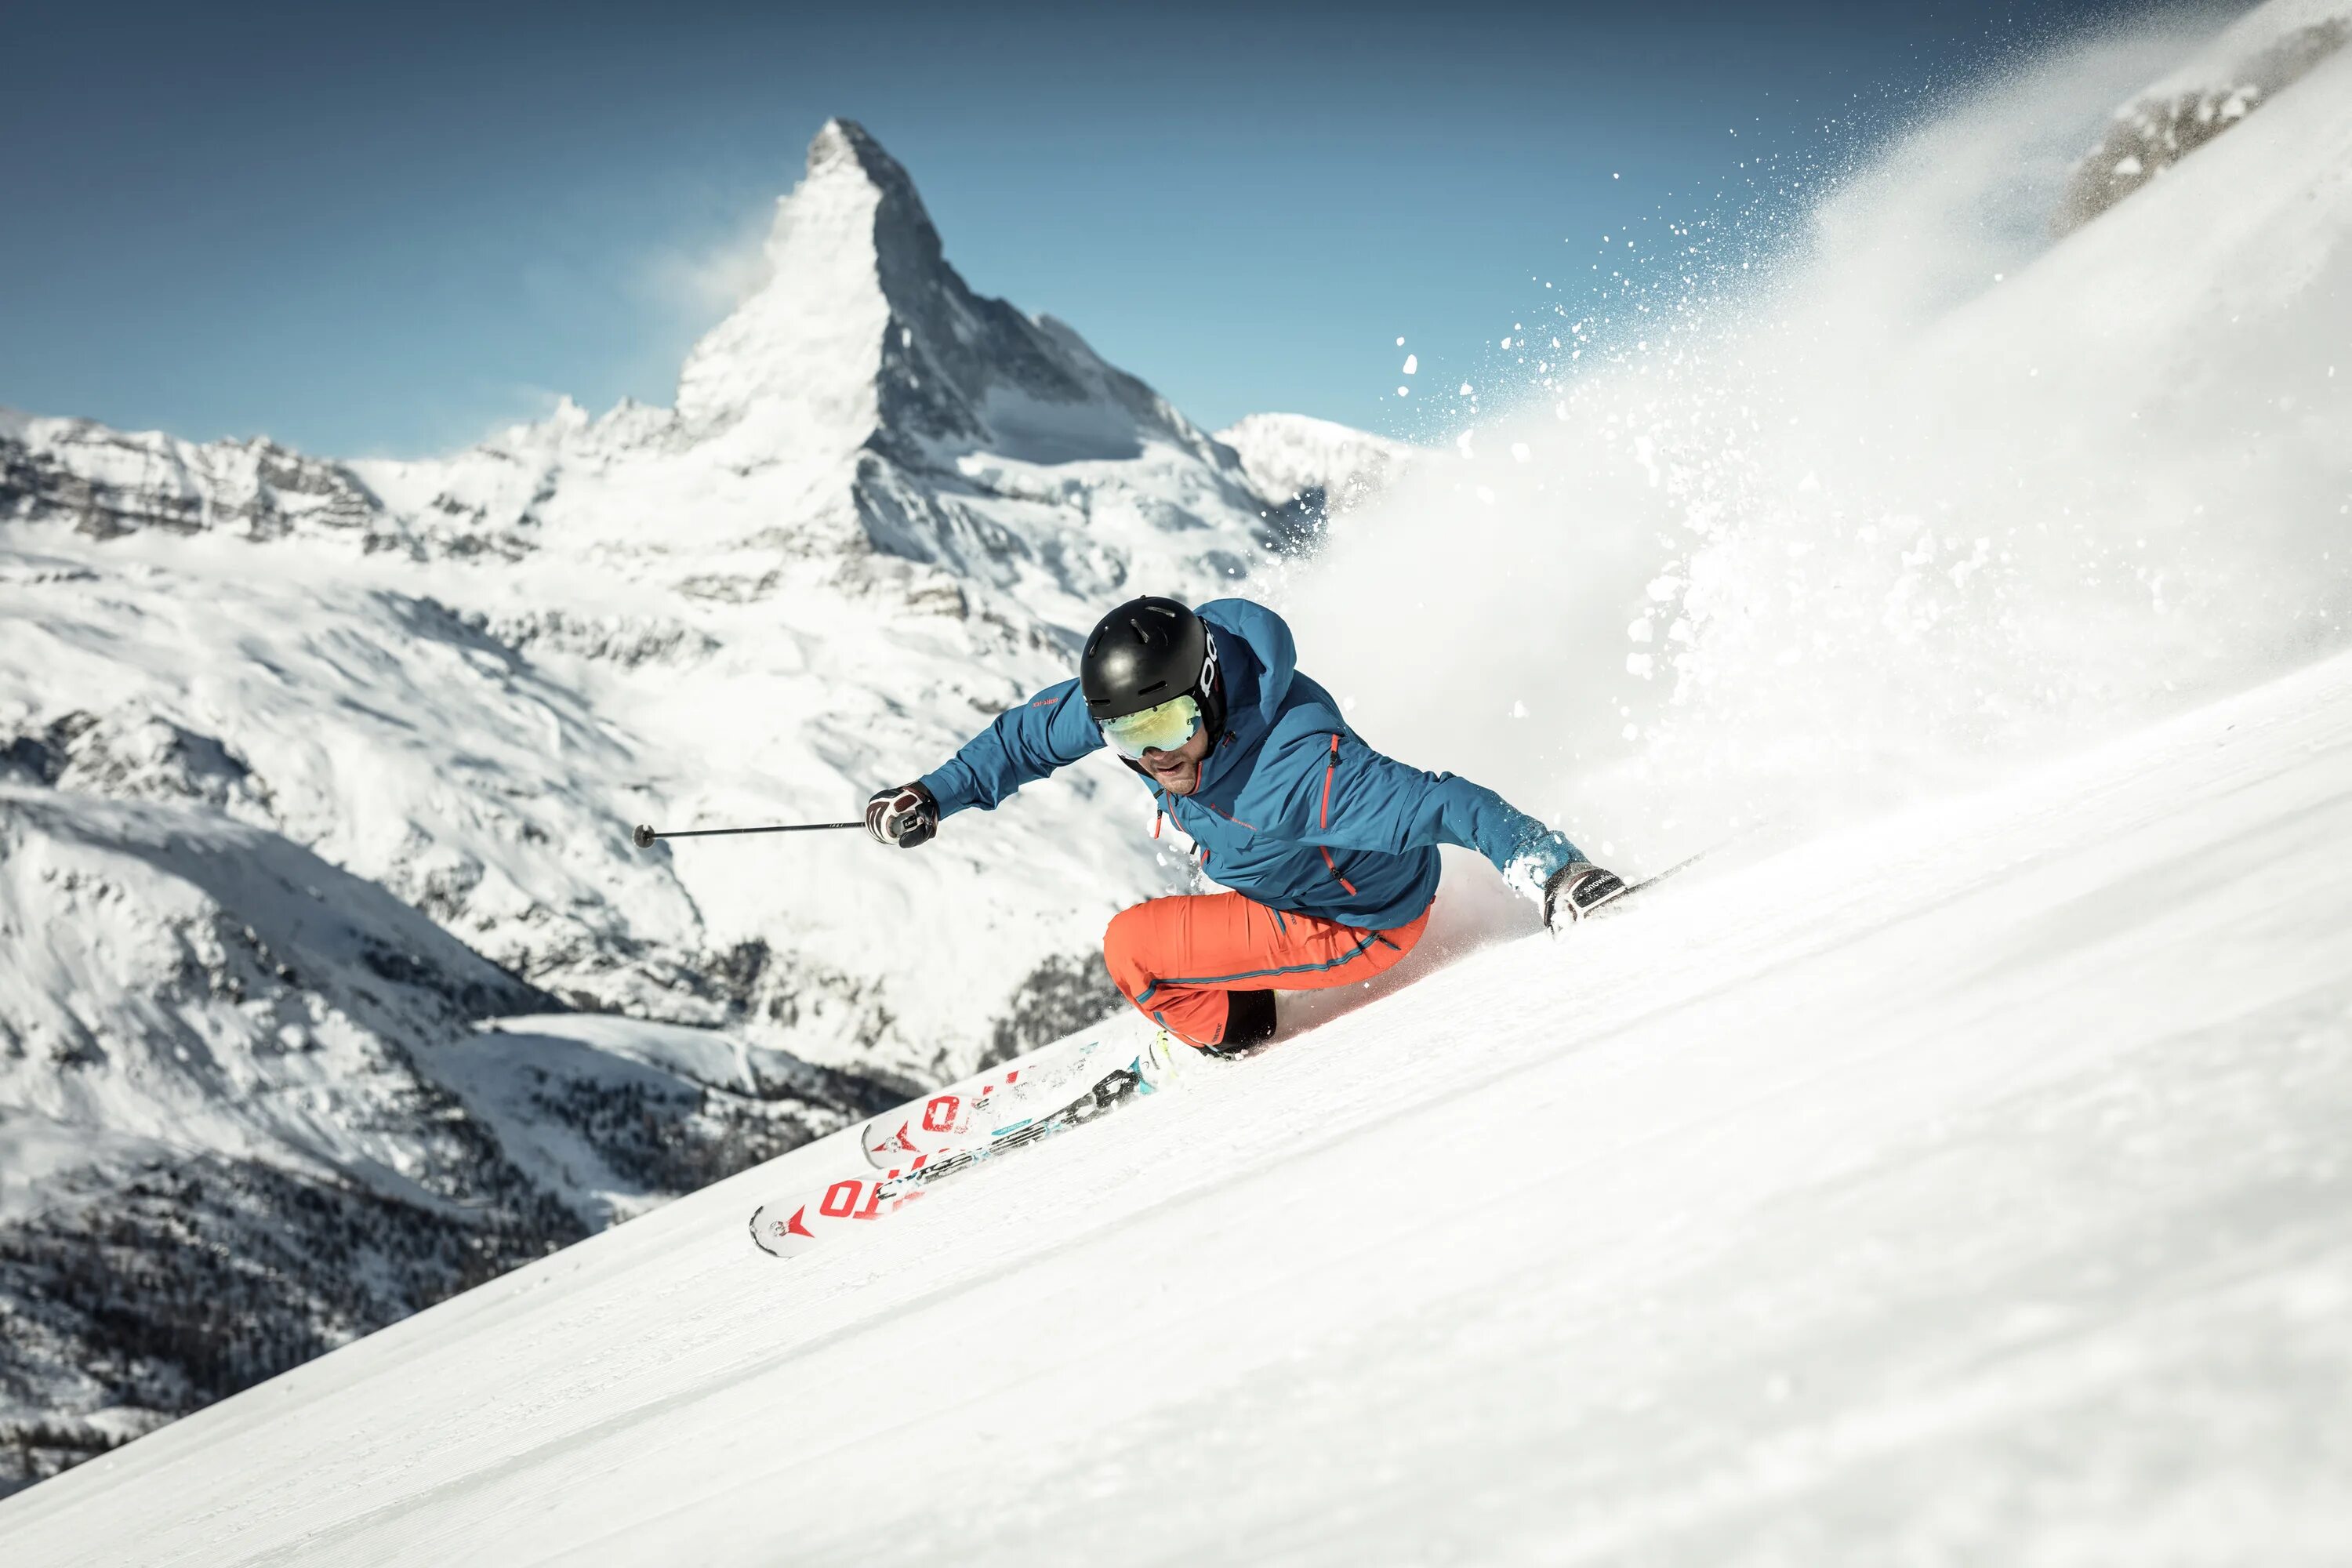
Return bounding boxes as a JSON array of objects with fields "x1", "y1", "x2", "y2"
[{"x1": 0, "y1": 659, "x2": 2352, "y2": 1568}]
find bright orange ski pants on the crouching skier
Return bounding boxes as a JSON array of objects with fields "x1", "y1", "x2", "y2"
[{"x1": 1103, "y1": 893, "x2": 1430, "y2": 1046}]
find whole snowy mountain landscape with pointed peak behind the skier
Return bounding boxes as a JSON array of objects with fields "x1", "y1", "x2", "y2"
[{"x1": 0, "y1": 122, "x2": 1392, "y2": 1486}]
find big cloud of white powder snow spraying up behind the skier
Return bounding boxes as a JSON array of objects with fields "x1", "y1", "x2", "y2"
[{"x1": 1282, "y1": 15, "x2": 2352, "y2": 872}]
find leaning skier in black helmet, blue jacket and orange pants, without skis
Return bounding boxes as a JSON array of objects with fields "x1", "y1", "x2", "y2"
[{"x1": 866, "y1": 597, "x2": 1625, "y2": 1053}]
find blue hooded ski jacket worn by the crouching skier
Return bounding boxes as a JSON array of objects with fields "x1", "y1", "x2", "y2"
[{"x1": 922, "y1": 600, "x2": 1583, "y2": 931}]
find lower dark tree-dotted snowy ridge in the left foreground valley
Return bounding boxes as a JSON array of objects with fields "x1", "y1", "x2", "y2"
[{"x1": 0, "y1": 789, "x2": 894, "y2": 1488}]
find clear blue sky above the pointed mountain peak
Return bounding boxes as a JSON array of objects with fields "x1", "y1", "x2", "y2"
[{"x1": 0, "y1": 0, "x2": 2131, "y2": 456}]
